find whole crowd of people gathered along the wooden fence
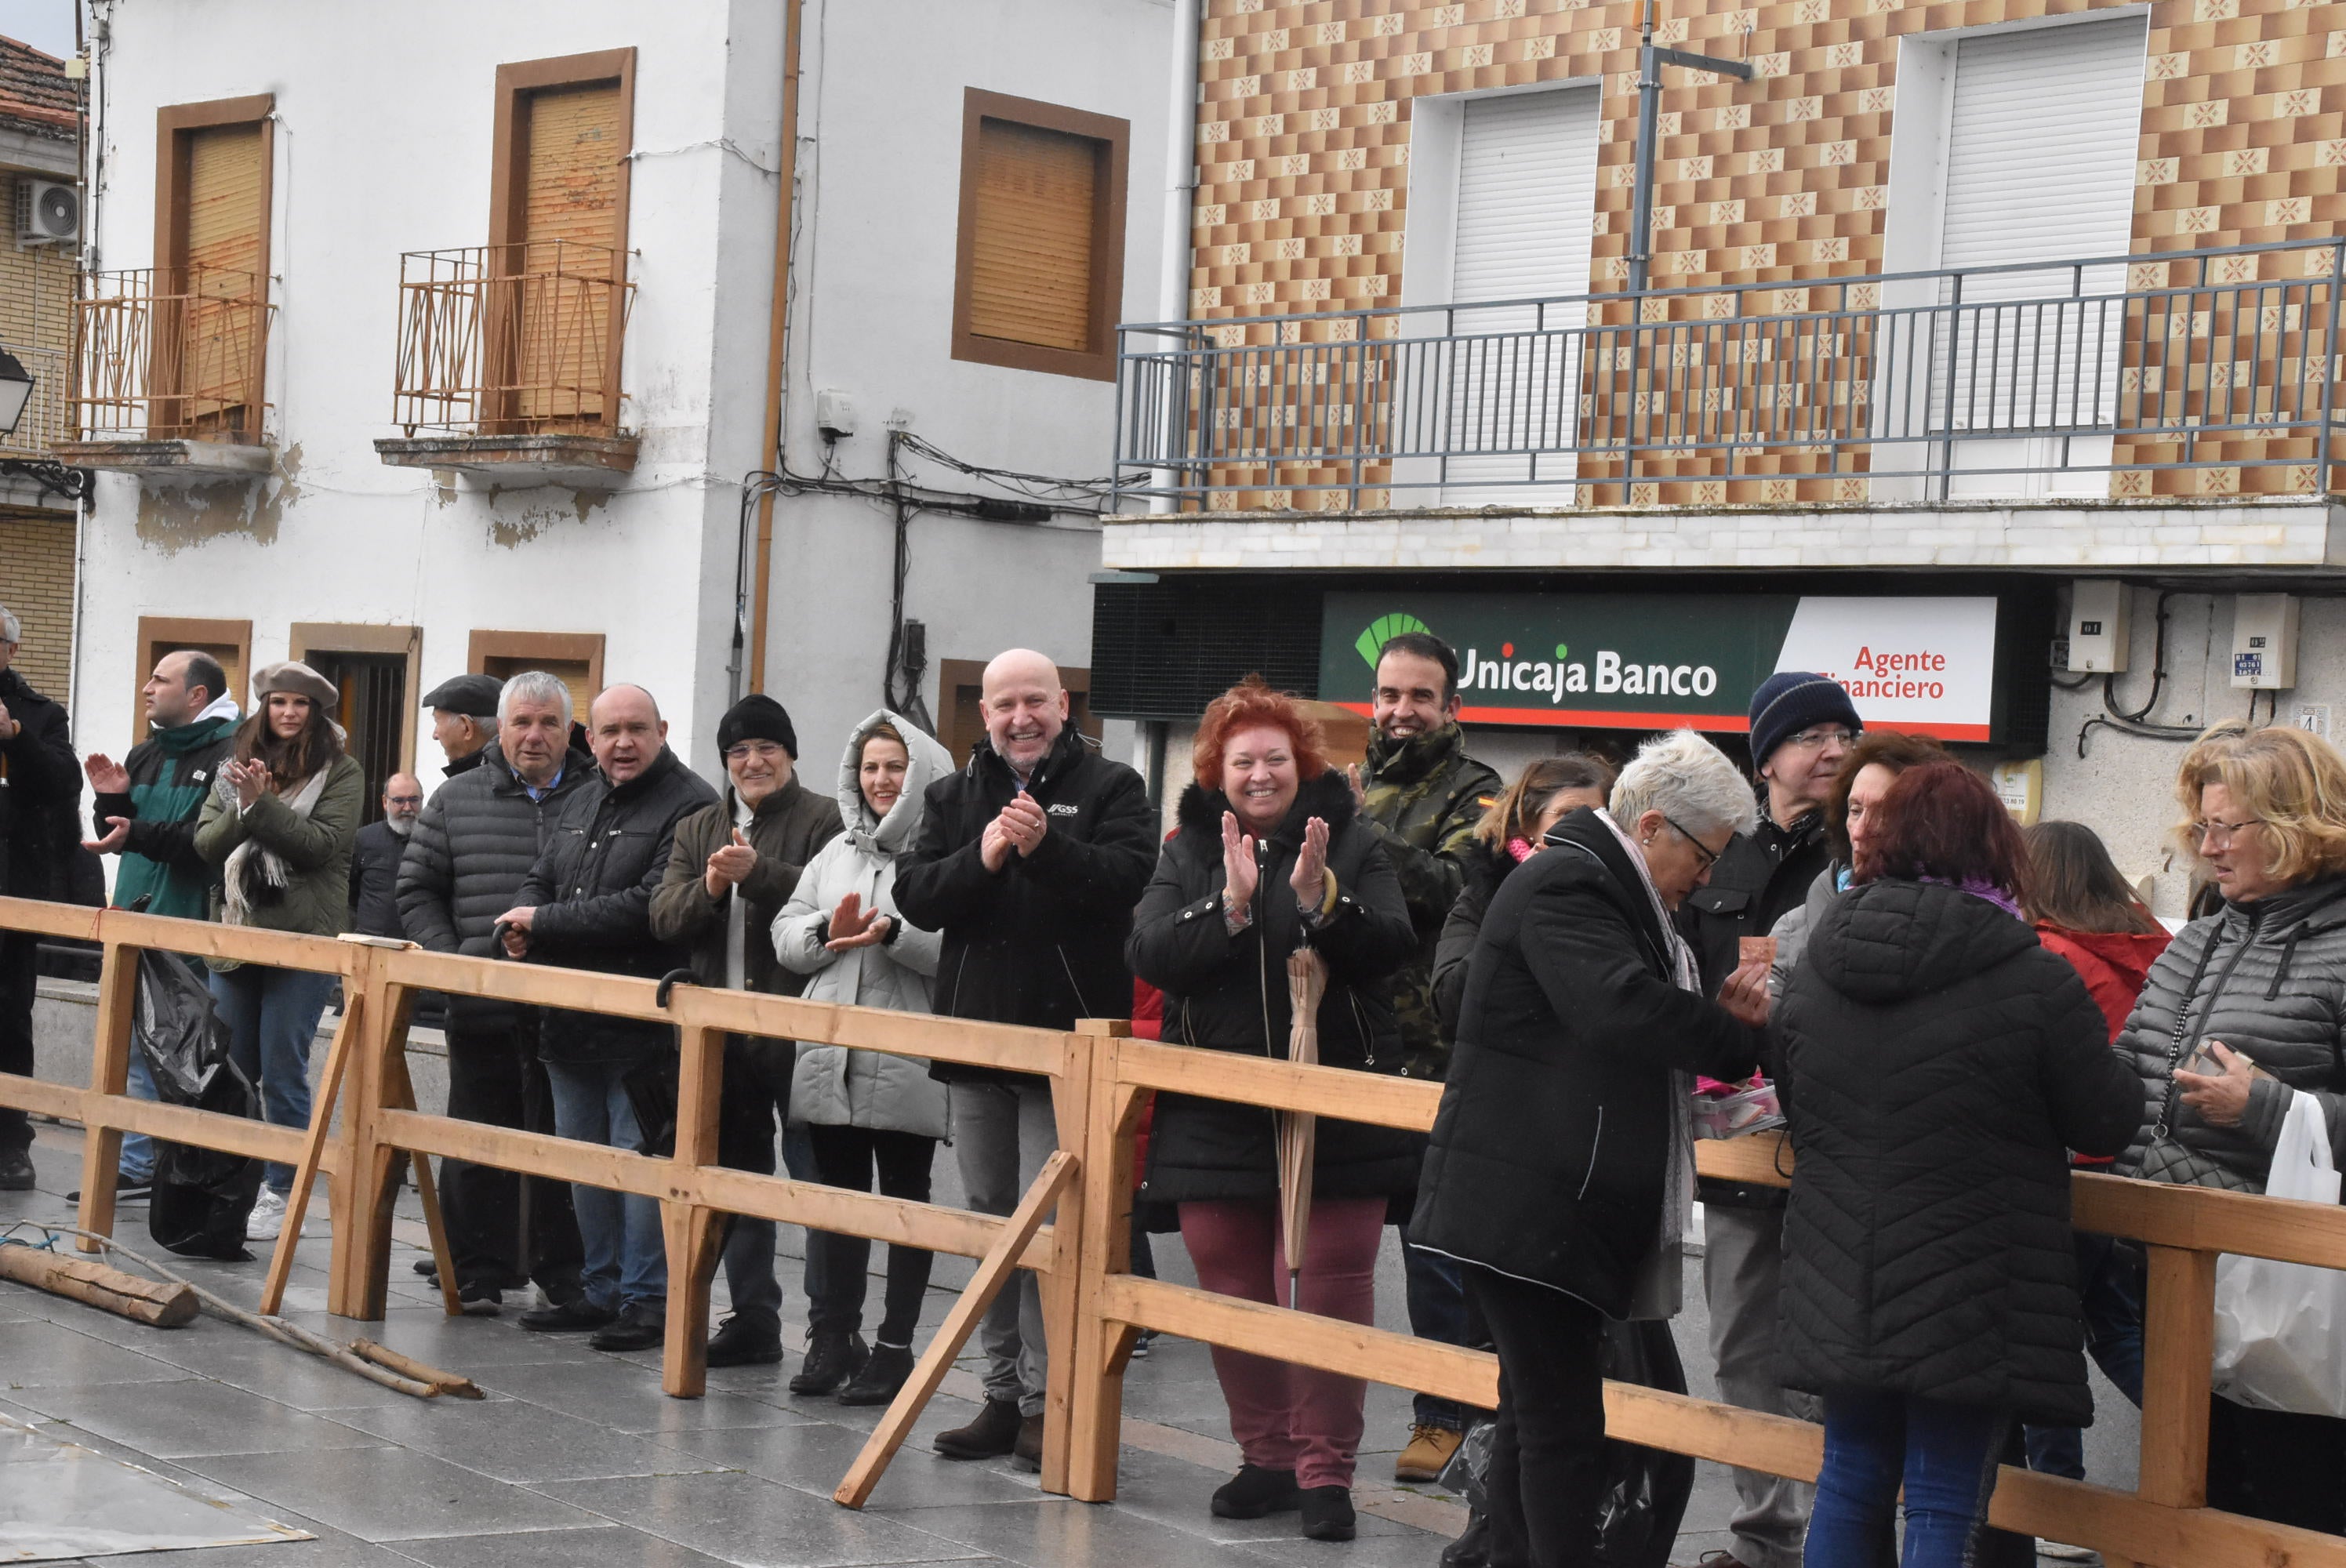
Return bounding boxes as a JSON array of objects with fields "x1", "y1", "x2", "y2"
[{"x1": 0, "y1": 596, "x2": 2346, "y2": 1568}]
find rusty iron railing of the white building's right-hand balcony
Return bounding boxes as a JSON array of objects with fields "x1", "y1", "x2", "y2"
[{"x1": 392, "y1": 239, "x2": 636, "y2": 437}]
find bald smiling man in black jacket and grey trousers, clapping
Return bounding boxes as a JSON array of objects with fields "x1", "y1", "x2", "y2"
[{"x1": 896, "y1": 648, "x2": 1157, "y2": 1467}]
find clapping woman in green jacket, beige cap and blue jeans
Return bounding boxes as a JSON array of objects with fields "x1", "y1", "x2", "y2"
[{"x1": 194, "y1": 659, "x2": 366, "y2": 1242}]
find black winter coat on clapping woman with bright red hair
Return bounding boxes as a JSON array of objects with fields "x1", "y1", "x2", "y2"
[{"x1": 1126, "y1": 772, "x2": 1419, "y2": 1204}]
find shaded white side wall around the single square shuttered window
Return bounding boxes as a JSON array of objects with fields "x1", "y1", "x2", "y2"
[{"x1": 760, "y1": 0, "x2": 1173, "y2": 779}]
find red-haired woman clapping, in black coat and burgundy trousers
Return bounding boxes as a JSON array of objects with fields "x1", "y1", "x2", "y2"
[{"x1": 1126, "y1": 676, "x2": 1417, "y2": 1540}]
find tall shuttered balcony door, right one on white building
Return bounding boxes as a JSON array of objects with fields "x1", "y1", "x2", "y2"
[{"x1": 481, "y1": 49, "x2": 636, "y2": 434}]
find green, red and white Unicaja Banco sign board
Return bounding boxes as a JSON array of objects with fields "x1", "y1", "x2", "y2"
[{"x1": 1320, "y1": 591, "x2": 1996, "y2": 739}]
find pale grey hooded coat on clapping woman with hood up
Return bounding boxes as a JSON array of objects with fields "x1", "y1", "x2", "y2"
[{"x1": 774, "y1": 709, "x2": 953, "y2": 1138}]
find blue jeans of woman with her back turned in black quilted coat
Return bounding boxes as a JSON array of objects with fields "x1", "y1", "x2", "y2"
[{"x1": 1802, "y1": 1392, "x2": 2013, "y2": 1568}]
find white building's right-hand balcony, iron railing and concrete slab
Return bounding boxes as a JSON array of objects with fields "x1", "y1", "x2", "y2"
[{"x1": 376, "y1": 239, "x2": 636, "y2": 486}]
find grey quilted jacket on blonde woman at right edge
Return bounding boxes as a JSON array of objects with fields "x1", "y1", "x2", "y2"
[{"x1": 2116, "y1": 878, "x2": 2346, "y2": 1192}]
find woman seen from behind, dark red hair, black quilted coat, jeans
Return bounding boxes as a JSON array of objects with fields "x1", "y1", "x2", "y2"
[{"x1": 1776, "y1": 763, "x2": 2144, "y2": 1568}]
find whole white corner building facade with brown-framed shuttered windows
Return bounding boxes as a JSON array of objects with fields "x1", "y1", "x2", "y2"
[{"x1": 64, "y1": 0, "x2": 1171, "y2": 802}]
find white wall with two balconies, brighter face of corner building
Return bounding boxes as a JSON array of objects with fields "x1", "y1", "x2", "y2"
[{"x1": 80, "y1": 0, "x2": 781, "y2": 779}]
